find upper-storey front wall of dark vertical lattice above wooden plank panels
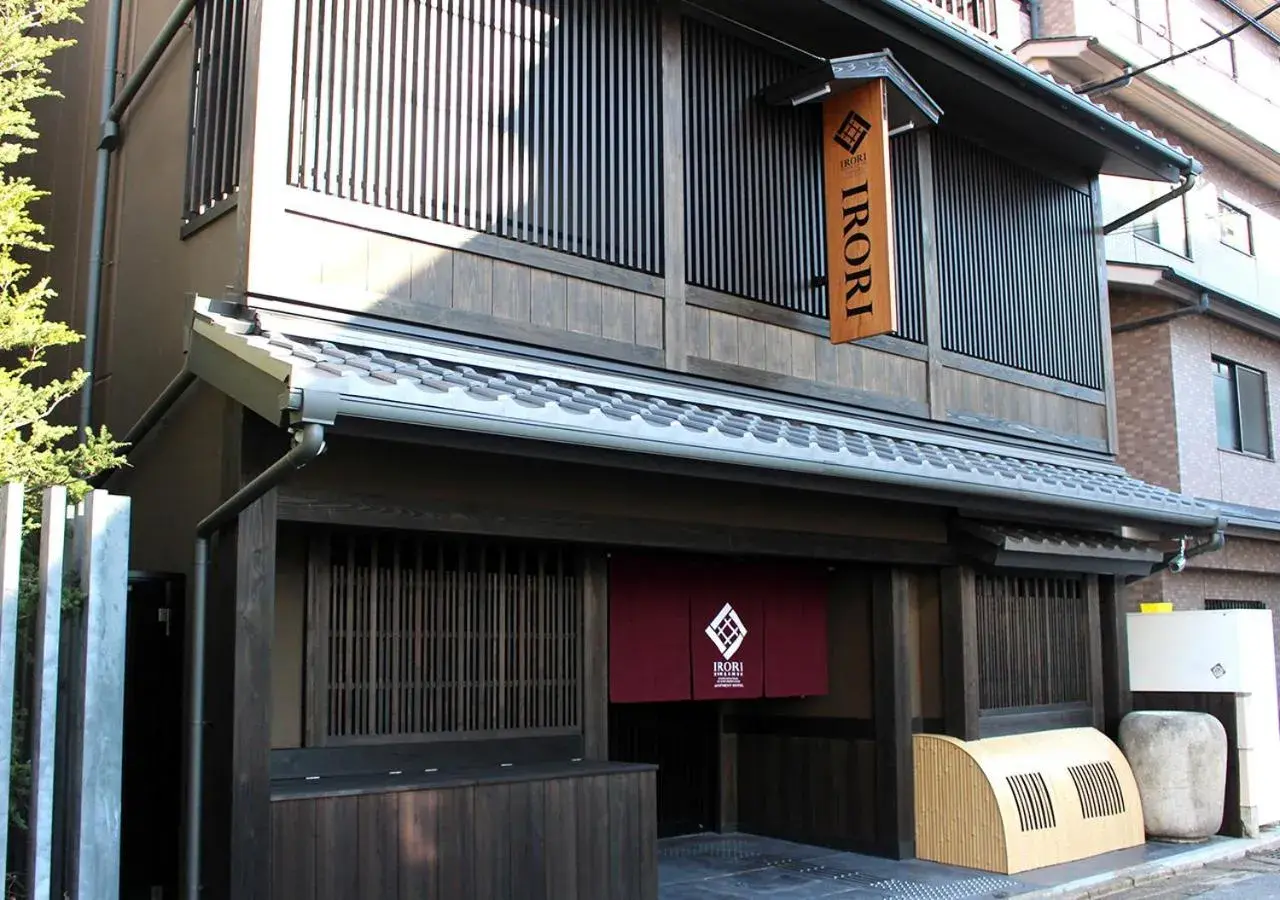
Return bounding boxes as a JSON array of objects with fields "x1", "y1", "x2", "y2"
[{"x1": 246, "y1": 0, "x2": 1114, "y2": 452}]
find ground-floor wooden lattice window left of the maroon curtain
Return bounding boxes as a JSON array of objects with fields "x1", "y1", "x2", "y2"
[{"x1": 307, "y1": 531, "x2": 582, "y2": 745}]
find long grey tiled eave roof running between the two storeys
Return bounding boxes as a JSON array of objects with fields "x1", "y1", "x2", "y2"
[{"x1": 189, "y1": 301, "x2": 1216, "y2": 527}]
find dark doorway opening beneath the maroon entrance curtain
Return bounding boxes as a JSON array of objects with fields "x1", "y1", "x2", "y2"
[{"x1": 609, "y1": 700, "x2": 719, "y2": 837}]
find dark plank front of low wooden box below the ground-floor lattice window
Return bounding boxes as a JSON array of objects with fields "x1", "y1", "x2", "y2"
[{"x1": 271, "y1": 772, "x2": 658, "y2": 900}]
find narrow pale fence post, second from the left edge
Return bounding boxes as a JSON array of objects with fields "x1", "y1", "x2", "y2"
[{"x1": 27, "y1": 486, "x2": 67, "y2": 900}]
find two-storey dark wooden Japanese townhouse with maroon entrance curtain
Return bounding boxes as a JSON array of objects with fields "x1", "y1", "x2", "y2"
[{"x1": 30, "y1": 0, "x2": 1221, "y2": 900}]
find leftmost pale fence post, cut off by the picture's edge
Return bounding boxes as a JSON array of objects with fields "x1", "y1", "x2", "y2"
[{"x1": 0, "y1": 483, "x2": 22, "y2": 890}]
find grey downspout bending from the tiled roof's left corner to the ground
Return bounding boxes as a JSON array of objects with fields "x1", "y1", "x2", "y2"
[{"x1": 183, "y1": 422, "x2": 325, "y2": 900}]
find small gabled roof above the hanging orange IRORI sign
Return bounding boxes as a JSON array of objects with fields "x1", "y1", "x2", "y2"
[{"x1": 764, "y1": 50, "x2": 942, "y2": 128}]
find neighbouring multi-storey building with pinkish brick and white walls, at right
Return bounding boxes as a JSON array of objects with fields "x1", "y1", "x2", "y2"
[{"x1": 1018, "y1": 0, "x2": 1280, "y2": 670}]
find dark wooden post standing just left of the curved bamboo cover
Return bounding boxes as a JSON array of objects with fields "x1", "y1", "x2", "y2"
[{"x1": 872, "y1": 568, "x2": 915, "y2": 859}]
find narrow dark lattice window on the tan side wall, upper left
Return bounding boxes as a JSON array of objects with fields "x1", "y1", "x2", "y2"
[{"x1": 184, "y1": 0, "x2": 247, "y2": 221}]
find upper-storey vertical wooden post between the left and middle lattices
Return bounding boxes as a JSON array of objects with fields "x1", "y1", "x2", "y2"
[{"x1": 662, "y1": 4, "x2": 689, "y2": 371}]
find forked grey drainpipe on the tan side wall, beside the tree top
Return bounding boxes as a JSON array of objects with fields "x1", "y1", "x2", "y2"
[{"x1": 78, "y1": 0, "x2": 196, "y2": 439}]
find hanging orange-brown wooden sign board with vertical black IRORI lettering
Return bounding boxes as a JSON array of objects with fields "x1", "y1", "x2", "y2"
[{"x1": 822, "y1": 78, "x2": 897, "y2": 343}]
